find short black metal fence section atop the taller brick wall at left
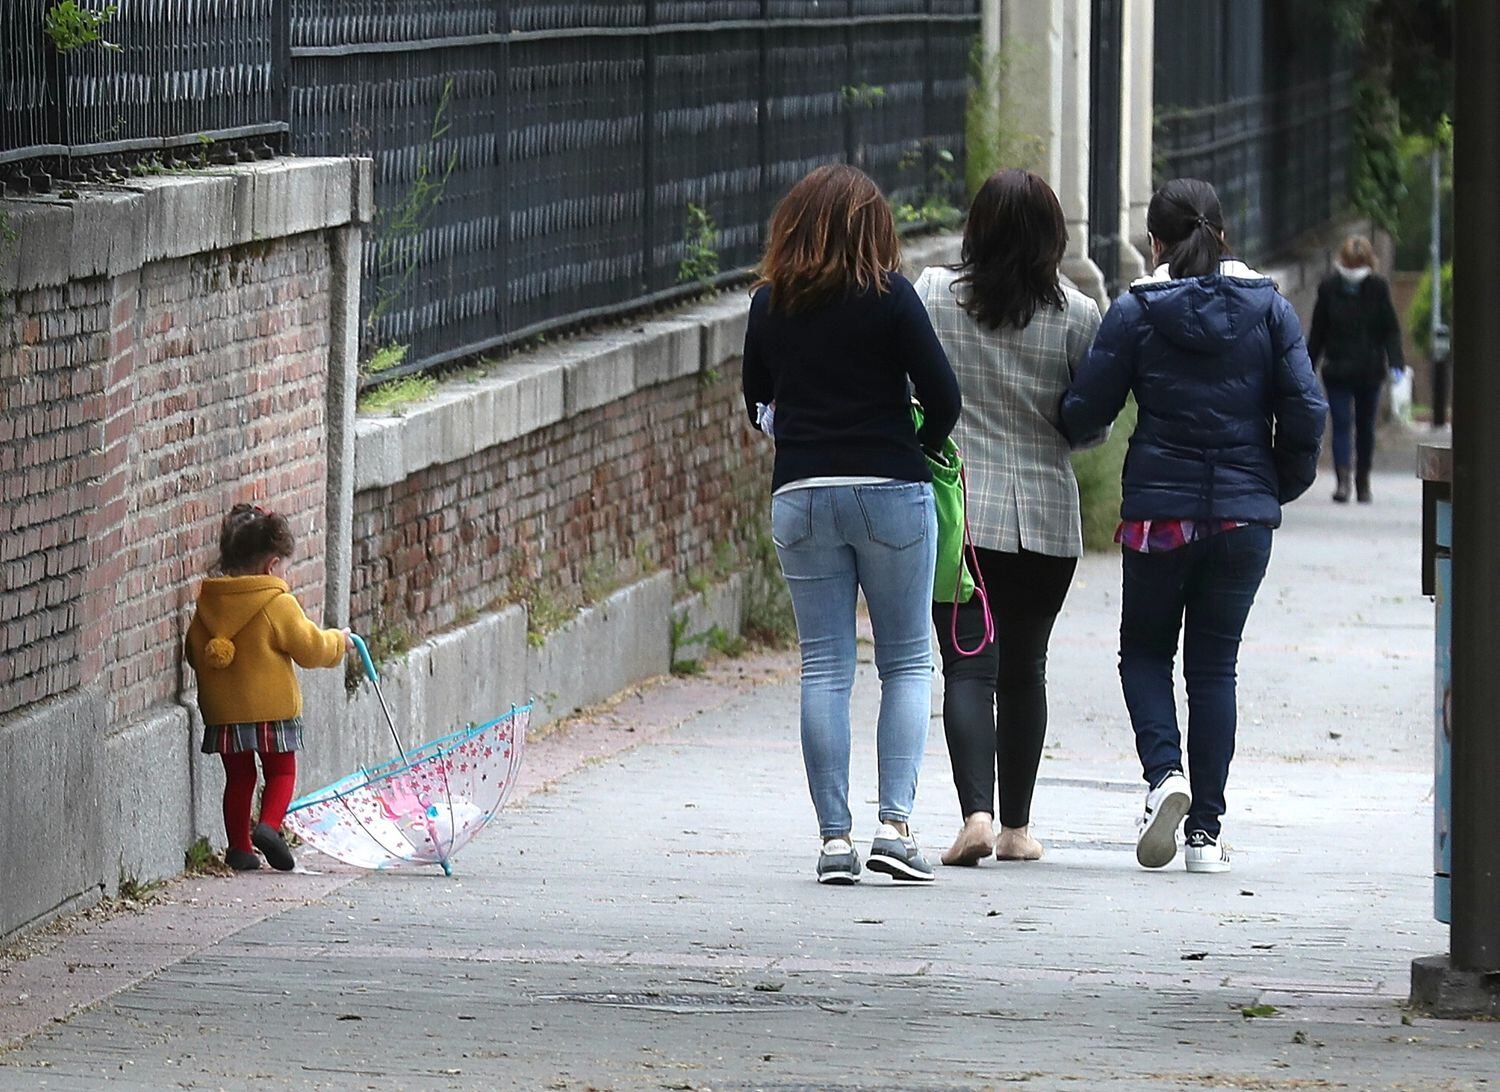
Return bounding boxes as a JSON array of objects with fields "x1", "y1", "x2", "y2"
[{"x1": 0, "y1": 0, "x2": 288, "y2": 189}]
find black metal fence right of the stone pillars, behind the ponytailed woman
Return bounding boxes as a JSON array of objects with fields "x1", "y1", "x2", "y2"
[{"x1": 1155, "y1": 0, "x2": 1353, "y2": 261}]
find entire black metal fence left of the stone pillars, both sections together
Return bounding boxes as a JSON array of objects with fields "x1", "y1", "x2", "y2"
[{"x1": 0, "y1": 0, "x2": 980, "y2": 377}]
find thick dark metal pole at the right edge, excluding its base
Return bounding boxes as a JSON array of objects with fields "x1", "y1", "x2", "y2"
[{"x1": 1449, "y1": 0, "x2": 1500, "y2": 974}]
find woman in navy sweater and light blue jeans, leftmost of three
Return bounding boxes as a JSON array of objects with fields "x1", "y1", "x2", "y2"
[{"x1": 744, "y1": 165, "x2": 960, "y2": 884}]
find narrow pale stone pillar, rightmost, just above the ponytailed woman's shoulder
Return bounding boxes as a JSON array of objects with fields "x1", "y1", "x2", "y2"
[{"x1": 1121, "y1": 0, "x2": 1157, "y2": 281}]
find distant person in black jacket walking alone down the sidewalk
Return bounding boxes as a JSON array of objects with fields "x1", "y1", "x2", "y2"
[{"x1": 1308, "y1": 236, "x2": 1406, "y2": 504}]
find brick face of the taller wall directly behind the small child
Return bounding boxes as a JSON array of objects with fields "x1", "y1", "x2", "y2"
[{"x1": 0, "y1": 233, "x2": 330, "y2": 723}]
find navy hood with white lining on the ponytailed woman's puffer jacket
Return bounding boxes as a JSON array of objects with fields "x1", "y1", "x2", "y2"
[{"x1": 1131, "y1": 261, "x2": 1277, "y2": 353}]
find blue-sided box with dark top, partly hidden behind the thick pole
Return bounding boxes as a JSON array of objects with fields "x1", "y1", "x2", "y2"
[{"x1": 1418, "y1": 444, "x2": 1454, "y2": 924}]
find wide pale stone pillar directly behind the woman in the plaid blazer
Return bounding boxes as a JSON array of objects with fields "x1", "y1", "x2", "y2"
[{"x1": 1001, "y1": 0, "x2": 1109, "y2": 308}]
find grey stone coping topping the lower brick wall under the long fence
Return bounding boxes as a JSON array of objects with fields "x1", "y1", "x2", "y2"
[{"x1": 354, "y1": 236, "x2": 959, "y2": 492}]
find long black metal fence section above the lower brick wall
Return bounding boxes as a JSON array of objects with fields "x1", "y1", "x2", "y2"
[{"x1": 290, "y1": 0, "x2": 980, "y2": 377}]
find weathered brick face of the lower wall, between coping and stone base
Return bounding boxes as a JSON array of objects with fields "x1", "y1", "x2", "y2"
[{"x1": 351, "y1": 365, "x2": 771, "y2": 638}]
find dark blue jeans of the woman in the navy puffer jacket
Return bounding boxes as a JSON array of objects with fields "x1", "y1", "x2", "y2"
[{"x1": 1121, "y1": 527, "x2": 1271, "y2": 837}]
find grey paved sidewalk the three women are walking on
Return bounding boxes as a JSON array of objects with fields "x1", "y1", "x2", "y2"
[{"x1": 0, "y1": 465, "x2": 1500, "y2": 1089}]
